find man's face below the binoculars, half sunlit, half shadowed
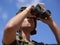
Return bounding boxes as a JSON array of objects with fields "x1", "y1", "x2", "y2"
[{"x1": 21, "y1": 17, "x2": 35, "y2": 31}]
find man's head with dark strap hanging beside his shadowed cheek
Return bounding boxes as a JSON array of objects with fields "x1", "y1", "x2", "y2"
[{"x1": 17, "y1": 7, "x2": 37, "y2": 35}]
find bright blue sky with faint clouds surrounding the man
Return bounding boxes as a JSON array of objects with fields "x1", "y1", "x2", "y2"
[{"x1": 0, "y1": 0, "x2": 60, "y2": 45}]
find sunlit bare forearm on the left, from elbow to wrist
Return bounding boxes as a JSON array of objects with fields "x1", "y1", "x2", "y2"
[{"x1": 7, "y1": 10, "x2": 27, "y2": 29}]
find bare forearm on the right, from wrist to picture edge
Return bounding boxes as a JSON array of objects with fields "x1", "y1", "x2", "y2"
[{"x1": 49, "y1": 21, "x2": 60, "y2": 44}]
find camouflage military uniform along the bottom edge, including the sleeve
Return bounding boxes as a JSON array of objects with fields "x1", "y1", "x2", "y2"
[{"x1": 3, "y1": 36, "x2": 57, "y2": 45}]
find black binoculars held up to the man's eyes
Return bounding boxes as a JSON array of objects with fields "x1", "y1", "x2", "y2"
[{"x1": 17, "y1": 4, "x2": 51, "y2": 19}]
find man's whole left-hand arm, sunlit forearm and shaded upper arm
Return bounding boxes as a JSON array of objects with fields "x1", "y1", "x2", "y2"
[{"x1": 2, "y1": 5, "x2": 32, "y2": 44}]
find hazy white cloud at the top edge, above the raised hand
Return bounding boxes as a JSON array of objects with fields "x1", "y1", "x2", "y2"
[{"x1": 16, "y1": 0, "x2": 41, "y2": 8}]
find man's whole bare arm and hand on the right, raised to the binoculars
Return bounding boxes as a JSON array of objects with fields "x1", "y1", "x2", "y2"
[{"x1": 39, "y1": 17, "x2": 60, "y2": 45}]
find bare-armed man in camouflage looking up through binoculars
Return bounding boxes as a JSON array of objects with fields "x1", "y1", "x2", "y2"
[{"x1": 3, "y1": 5, "x2": 60, "y2": 45}]
